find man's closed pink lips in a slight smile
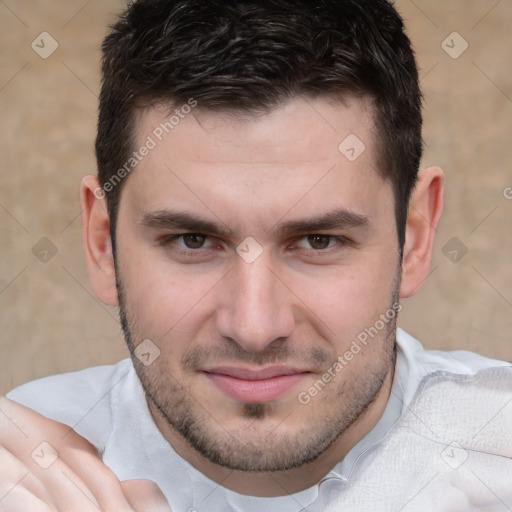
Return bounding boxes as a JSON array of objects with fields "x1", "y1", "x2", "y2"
[{"x1": 202, "y1": 366, "x2": 311, "y2": 403}]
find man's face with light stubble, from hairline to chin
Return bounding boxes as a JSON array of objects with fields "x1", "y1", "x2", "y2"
[{"x1": 116, "y1": 99, "x2": 400, "y2": 471}]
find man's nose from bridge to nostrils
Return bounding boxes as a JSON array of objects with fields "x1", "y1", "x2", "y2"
[{"x1": 216, "y1": 256, "x2": 295, "y2": 353}]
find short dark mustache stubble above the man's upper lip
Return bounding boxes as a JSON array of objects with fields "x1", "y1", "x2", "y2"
[{"x1": 181, "y1": 340, "x2": 332, "y2": 370}]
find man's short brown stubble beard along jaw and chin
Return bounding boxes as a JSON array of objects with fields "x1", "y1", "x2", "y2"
[{"x1": 117, "y1": 275, "x2": 399, "y2": 472}]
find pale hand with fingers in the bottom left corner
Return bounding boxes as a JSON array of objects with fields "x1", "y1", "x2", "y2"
[{"x1": 0, "y1": 397, "x2": 172, "y2": 512}]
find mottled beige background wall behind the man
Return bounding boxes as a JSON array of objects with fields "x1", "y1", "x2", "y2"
[{"x1": 0, "y1": 0, "x2": 512, "y2": 393}]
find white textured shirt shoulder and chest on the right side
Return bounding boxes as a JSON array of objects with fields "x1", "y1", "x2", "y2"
[{"x1": 334, "y1": 331, "x2": 512, "y2": 512}]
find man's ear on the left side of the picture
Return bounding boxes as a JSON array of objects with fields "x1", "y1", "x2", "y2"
[{"x1": 80, "y1": 176, "x2": 119, "y2": 306}]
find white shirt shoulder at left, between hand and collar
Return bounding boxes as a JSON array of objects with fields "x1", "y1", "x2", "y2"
[{"x1": 7, "y1": 359, "x2": 135, "y2": 447}]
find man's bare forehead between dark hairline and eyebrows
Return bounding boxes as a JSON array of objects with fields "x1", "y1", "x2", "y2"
[{"x1": 121, "y1": 94, "x2": 390, "y2": 232}]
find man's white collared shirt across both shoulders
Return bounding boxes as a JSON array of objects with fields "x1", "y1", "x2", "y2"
[{"x1": 7, "y1": 329, "x2": 512, "y2": 512}]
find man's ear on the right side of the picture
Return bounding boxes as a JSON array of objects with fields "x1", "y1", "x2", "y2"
[{"x1": 400, "y1": 167, "x2": 444, "y2": 298}]
